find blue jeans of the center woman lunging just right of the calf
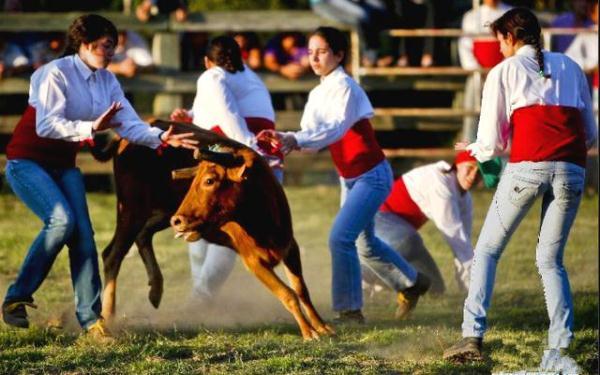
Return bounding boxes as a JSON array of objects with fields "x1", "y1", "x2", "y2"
[{"x1": 329, "y1": 161, "x2": 416, "y2": 311}]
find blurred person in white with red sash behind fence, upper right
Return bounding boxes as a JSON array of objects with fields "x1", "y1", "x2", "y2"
[{"x1": 458, "y1": 0, "x2": 510, "y2": 139}]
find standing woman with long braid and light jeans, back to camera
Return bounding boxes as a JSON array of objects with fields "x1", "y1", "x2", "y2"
[{"x1": 444, "y1": 8, "x2": 597, "y2": 373}]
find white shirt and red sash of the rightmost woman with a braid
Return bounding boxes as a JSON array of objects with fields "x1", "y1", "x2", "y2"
[{"x1": 467, "y1": 45, "x2": 597, "y2": 165}]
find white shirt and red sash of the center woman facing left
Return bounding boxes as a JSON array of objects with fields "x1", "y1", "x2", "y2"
[{"x1": 290, "y1": 67, "x2": 385, "y2": 178}]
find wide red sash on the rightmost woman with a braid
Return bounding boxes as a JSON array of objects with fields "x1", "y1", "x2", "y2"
[{"x1": 510, "y1": 105, "x2": 587, "y2": 167}]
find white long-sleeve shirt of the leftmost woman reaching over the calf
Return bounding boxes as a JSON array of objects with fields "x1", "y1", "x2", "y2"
[{"x1": 29, "y1": 54, "x2": 162, "y2": 148}]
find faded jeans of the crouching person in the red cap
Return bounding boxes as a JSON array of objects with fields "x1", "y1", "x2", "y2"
[{"x1": 358, "y1": 211, "x2": 445, "y2": 294}]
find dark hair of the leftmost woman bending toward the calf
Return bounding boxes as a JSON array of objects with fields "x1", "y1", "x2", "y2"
[{"x1": 63, "y1": 14, "x2": 119, "y2": 56}]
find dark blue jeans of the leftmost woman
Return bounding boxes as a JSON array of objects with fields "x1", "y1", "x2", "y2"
[{"x1": 5, "y1": 159, "x2": 102, "y2": 328}]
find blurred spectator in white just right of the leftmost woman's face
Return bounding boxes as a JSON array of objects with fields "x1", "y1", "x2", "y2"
[{"x1": 108, "y1": 30, "x2": 153, "y2": 78}]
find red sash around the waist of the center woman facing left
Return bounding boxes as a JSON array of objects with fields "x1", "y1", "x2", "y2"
[{"x1": 329, "y1": 119, "x2": 385, "y2": 178}]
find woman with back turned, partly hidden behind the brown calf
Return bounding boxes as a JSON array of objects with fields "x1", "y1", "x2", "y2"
[{"x1": 171, "y1": 36, "x2": 283, "y2": 301}]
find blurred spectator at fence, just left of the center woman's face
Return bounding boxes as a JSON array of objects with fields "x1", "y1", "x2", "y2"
[{"x1": 264, "y1": 32, "x2": 309, "y2": 79}]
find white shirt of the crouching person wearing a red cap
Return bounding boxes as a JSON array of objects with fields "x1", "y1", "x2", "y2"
[{"x1": 402, "y1": 161, "x2": 473, "y2": 263}]
